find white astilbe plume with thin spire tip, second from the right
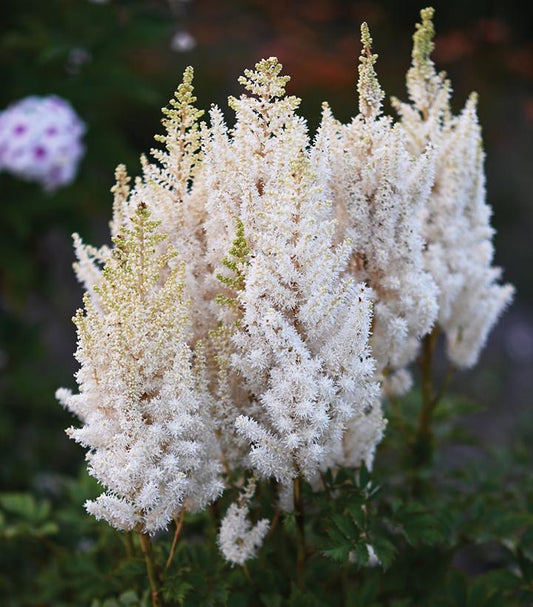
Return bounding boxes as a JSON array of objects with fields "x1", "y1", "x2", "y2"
[{"x1": 318, "y1": 24, "x2": 437, "y2": 391}]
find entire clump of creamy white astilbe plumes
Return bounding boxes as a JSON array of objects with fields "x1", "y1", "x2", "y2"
[{"x1": 58, "y1": 7, "x2": 511, "y2": 564}]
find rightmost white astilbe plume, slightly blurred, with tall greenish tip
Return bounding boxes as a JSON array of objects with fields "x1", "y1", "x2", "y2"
[{"x1": 393, "y1": 8, "x2": 513, "y2": 368}]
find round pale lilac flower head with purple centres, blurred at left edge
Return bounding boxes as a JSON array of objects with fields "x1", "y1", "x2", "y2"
[{"x1": 0, "y1": 95, "x2": 85, "y2": 191}]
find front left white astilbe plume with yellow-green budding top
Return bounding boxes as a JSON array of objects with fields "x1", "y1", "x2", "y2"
[{"x1": 57, "y1": 204, "x2": 221, "y2": 533}]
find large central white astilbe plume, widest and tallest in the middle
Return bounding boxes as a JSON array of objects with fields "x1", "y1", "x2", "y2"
[{"x1": 205, "y1": 58, "x2": 379, "y2": 483}]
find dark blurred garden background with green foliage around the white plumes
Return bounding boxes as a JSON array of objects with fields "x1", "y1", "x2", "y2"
[{"x1": 0, "y1": 0, "x2": 533, "y2": 607}]
